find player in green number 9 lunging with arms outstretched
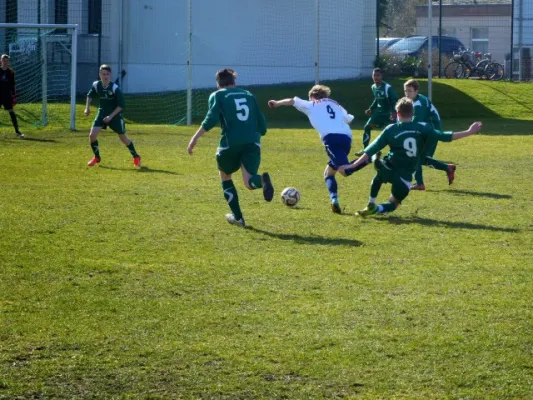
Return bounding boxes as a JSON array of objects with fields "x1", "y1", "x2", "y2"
[{"x1": 340, "y1": 97, "x2": 483, "y2": 217}]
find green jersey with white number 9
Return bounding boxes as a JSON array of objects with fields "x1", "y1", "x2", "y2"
[{"x1": 364, "y1": 122, "x2": 452, "y2": 176}]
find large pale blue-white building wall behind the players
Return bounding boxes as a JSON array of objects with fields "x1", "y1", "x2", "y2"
[{"x1": 109, "y1": 0, "x2": 375, "y2": 93}]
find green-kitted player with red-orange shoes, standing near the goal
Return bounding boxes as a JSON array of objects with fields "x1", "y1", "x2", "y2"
[{"x1": 84, "y1": 64, "x2": 141, "y2": 167}]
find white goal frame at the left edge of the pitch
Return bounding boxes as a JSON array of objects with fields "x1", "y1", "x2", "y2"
[{"x1": 0, "y1": 23, "x2": 78, "y2": 131}]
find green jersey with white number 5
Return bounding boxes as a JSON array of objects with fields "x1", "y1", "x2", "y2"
[{"x1": 202, "y1": 87, "x2": 267, "y2": 148}]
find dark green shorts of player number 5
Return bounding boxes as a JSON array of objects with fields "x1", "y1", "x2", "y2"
[{"x1": 217, "y1": 143, "x2": 261, "y2": 175}]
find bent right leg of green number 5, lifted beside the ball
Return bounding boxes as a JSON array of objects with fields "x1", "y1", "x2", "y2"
[{"x1": 241, "y1": 143, "x2": 274, "y2": 201}]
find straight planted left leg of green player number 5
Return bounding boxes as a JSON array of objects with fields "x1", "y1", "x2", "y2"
[{"x1": 216, "y1": 148, "x2": 245, "y2": 226}]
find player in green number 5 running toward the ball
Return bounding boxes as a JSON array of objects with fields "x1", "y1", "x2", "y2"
[{"x1": 187, "y1": 68, "x2": 274, "y2": 227}]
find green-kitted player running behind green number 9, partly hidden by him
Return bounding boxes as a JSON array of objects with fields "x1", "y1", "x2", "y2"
[{"x1": 404, "y1": 79, "x2": 456, "y2": 190}]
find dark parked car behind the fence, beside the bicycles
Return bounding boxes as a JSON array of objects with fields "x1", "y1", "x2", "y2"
[{"x1": 385, "y1": 36, "x2": 465, "y2": 58}]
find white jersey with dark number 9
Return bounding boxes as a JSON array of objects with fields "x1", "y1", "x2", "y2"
[{"x1": 293, "y1": 97, "x2": 353, "y2": 140}]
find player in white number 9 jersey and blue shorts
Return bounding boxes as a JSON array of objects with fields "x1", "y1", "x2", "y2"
[{"x1": 268, "y1": 85, "x2": 366, "y2": 214}]
